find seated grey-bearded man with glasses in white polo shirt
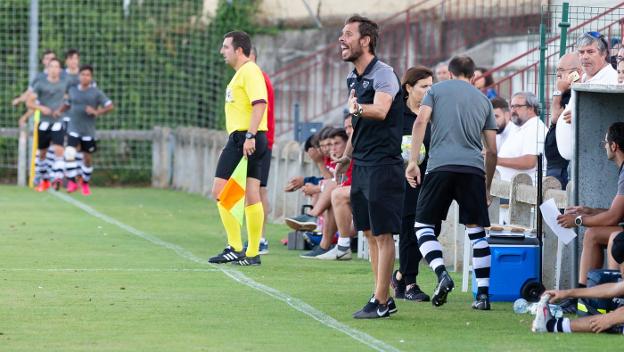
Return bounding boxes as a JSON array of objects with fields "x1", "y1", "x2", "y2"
[{"x1": 496, "y1": 92, "x2": 546, "y2": 182}]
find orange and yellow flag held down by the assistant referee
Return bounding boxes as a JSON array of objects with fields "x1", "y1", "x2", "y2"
[{"x1": 219, "y1": 158, "x2": 247, "y2": 226}]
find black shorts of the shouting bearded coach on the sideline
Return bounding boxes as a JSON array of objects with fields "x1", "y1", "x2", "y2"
[{"x1": 351, "y1": 164, "x2": 405, "y2": 236}]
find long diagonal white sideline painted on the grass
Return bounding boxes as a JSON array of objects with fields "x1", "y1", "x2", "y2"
[{"x1": 51, "y1": 191, "x2": 399, "y2": 351}]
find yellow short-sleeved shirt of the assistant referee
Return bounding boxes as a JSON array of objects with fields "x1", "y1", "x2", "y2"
[{"x1": 225, "y1": 61, "x2": 268, "y2": 134}]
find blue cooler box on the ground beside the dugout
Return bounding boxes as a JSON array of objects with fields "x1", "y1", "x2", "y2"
[{"x1": 472, "y1": 236, "x2": 540, "y2": 302}]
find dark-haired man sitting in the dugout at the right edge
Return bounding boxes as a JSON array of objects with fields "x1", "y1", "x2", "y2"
[{"x1": 557, "y1": 122, "x2": 624, "y2": 312}]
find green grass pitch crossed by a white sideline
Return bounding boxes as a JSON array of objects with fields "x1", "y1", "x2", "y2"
[{"x1": 0, "y1": 186, "x2": 622, "y2": 351}]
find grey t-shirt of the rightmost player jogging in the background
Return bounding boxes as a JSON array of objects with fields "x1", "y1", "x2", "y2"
[{"x1": 67, "y1": 86, "x2": 112, "y2": 138}]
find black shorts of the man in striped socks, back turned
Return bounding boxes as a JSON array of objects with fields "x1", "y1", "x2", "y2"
[{"x1": 416, "y1": 171, "x2": 490, "y2": 227}]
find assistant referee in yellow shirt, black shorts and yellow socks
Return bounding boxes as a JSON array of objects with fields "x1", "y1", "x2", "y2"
[{"x1": 208, "y1": 31, "x2": 268, "y2": 265}]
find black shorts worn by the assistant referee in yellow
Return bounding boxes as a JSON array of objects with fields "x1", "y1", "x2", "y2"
[{"x1": 215, "y1": 131, "x2": 267, "y2": 180}]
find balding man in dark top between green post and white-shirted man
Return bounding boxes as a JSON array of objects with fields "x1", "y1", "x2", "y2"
[{"x1": 544, "y1": 53, "x2": 583, "y2": 189}]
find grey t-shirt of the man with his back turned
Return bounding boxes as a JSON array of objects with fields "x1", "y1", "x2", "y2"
[{"x1": 422, "y1": 79, "x2": 498, "y2": 172}]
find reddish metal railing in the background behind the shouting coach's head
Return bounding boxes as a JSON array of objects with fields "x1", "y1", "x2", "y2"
[{"x1": 272, "y1": 0, "x2": 543, "y2": 136}]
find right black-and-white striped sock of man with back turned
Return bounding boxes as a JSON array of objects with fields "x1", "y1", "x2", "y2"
[{"x1": 466, "y1": 227, "x2": 492, "y2": 295}]
